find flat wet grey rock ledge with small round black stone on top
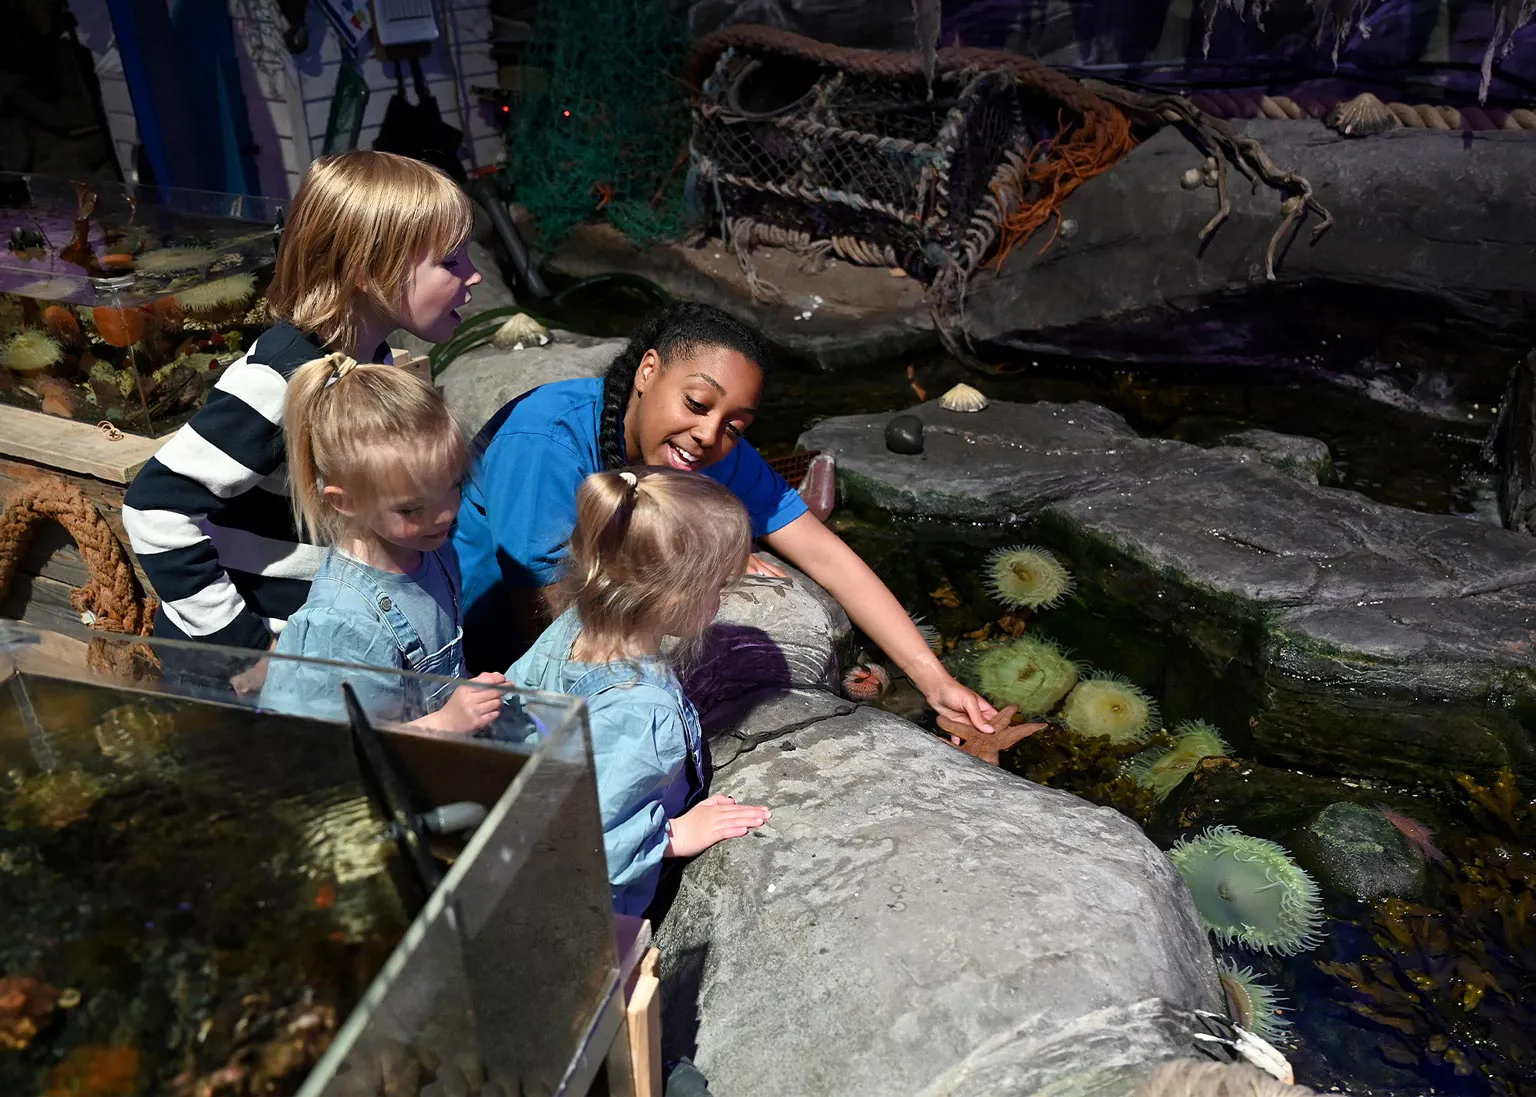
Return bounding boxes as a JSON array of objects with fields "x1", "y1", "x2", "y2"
[{"x1": 802, "y1": 403, "x2": 1536, "y2": 780}]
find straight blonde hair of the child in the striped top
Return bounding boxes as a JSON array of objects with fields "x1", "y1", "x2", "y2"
[{"x1": 267, "y1": 149, "x2": 475, "y2": 355}]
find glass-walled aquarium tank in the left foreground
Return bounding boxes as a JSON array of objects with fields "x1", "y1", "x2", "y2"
[{"x1": 0, "y1": 622, "x2": 622, "y2": 1097}]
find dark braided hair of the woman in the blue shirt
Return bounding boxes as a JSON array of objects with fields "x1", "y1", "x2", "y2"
[{"x1": 598, "y1": 301, "x2": 770, "y2": 472}]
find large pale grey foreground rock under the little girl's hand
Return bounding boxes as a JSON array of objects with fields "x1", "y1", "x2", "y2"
[{"x1": 659, "y1": 690, "x2": 1220, "y2": 1097}]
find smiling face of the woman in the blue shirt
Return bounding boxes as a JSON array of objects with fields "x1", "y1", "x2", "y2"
[{"x1": 624, "y1": 347, "x2": 763, "y2": 472}]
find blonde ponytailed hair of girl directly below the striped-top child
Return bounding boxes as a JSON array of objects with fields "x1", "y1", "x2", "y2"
[{"x1": 283, "y1": 355, "x2": 467, "y2": 544}]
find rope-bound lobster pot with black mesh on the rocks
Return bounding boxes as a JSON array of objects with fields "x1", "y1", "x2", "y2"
[{"x1": 691, "y1": 49, "x2": 1028, "y2": 280}]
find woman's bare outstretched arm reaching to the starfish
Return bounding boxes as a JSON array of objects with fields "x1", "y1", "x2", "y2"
[{"x1": 763, "y1": 513, "x2": 997, "y2": 731}]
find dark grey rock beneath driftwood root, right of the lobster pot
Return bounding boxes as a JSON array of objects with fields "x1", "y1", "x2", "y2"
[{"x1": 966, "y1": 120, "x2": 1536, "y2": 346}]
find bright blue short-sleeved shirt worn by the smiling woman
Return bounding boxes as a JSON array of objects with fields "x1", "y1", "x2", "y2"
[{"x1": 453, "y1": 378, "x2": 806, "y2": 670}]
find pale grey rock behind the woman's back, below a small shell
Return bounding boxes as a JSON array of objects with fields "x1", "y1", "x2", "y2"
[{"x1": 438, "y1": 332, "x2": 624, "y2": 432}]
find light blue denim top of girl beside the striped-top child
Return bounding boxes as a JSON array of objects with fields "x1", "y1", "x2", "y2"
[{"x1": 260, "y1": 545, "x2": 467, "y2": 722}]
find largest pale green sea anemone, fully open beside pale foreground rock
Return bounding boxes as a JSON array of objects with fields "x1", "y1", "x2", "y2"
[{"x1": 1167, "y1": 827, "x2": 1322, "y2": 956}]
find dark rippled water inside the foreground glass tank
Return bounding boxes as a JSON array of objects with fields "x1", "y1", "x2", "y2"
[{"x1": 0, "y1": 678, "x2": 409, "y2": 1097}]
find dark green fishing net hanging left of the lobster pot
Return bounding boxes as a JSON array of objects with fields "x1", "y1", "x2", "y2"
[{"x1": 508, "y1": 0, "x2": 688, "y2": 243}]
